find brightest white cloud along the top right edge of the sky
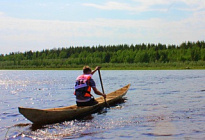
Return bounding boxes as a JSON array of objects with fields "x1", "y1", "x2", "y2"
[{"x1": 83, "y1": 0, "x2": 205, "y2": 12}]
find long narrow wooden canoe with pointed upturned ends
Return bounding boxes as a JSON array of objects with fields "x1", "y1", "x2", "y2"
[{"x1": 18, "y1": 84, "x2": 130, "y2": 125}]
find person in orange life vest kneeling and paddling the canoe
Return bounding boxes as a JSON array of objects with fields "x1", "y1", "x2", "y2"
[{"x1": 74, "y1": 66, "x2": 106, "y2": 106}]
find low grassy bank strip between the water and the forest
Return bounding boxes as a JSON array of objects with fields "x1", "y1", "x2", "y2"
[{"x1": 0, "y1": 61, "x2": 205, "y2": 70}]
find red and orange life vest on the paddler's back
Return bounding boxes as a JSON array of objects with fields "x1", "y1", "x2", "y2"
[{"x1": 74, "y1": 74, "x2": 92, "y2": 97}]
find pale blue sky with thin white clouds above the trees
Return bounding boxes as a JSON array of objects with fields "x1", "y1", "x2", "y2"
[{"x1": 0, "y1": 0, "x2": 205, "y2": 54}]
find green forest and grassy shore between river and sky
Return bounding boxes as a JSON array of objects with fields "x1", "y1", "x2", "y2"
[{"x1": 0, "y1": 41, "x2": 205, "y2": 69}]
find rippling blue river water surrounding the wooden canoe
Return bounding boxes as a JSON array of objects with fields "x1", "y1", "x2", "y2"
[{"x1": 0, "y1": 70, "x2": 205, "y2": 140}]
